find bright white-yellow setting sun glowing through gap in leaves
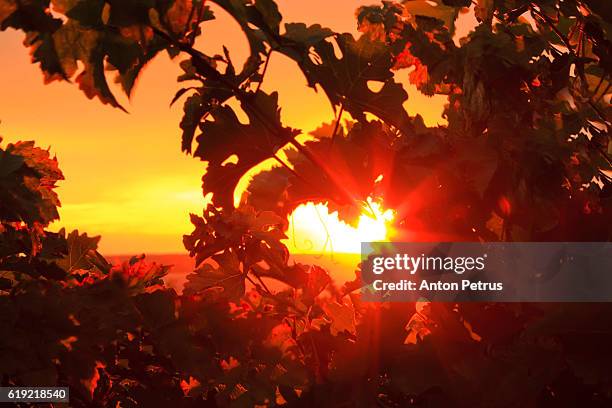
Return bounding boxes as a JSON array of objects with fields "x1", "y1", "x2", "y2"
[{"x1": 285, "y1": 198, "x2": 395, "y2": 254}]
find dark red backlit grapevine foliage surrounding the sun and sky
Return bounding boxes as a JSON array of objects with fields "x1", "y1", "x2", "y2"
[{"x1": 0, "y1": 0, "x2": 612, "y2": 407}]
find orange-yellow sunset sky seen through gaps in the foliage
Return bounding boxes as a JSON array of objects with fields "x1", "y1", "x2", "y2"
[{"x1": 0, "y1": 0, "x2": 464, "y2": 254}]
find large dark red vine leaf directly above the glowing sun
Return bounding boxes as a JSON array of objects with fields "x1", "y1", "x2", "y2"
[{"x1": 268, "y1": 121, "x2": 393, "y2": 225}]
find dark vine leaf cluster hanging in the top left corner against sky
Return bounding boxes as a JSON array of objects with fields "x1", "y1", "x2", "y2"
[{"x1": 0, "y1": 0, "x2": 194, "y2": 110}]
